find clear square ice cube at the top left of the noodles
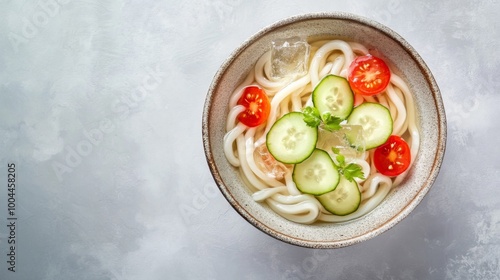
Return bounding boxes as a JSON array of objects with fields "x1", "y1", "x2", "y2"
[{"x1": 271, "y1": 37, "x2": 310, "y2": 79}]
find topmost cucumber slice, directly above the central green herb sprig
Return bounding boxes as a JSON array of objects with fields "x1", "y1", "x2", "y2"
[{"x1": 312, "y1": 75, "x2": 354, "y2": 119}]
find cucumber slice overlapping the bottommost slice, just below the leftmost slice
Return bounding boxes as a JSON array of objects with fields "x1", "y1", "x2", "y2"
[{"x1": 292, "y1": 149, "x2": 340, "y2": 195}]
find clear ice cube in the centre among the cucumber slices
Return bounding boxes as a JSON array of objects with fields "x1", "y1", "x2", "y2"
[{"x1": 316, "y1": 125, "x2": 365, "y2": 162}]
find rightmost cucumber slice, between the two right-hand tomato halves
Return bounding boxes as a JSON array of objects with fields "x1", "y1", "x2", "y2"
[{"x1": 347, "y1": 102, "x2": 392, "y2": 150}]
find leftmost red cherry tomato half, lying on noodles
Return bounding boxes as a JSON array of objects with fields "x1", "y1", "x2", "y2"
[{"x1": 238, "y1": 86, "x2": 271, "y2": 127}]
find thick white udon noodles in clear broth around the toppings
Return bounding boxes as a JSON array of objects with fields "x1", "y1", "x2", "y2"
[{"x1": 224, "y1": 39, "x2": 420, "y2": 224}]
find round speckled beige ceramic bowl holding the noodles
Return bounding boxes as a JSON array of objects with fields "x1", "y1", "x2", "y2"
[{"x1": 203, "y1": 13, "x2": 446, "y2": 248}]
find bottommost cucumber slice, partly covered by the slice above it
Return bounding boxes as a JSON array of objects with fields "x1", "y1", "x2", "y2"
[{"x1": 317, "y1": 176, "x2": 361, "y2": 216}]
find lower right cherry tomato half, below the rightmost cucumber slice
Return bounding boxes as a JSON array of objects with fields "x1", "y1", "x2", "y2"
[{"x1": 373, "y1": 135, "x2": 411, "y2": 177}]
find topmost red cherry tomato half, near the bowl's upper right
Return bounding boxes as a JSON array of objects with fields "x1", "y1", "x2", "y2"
[{"x1": 347, "y1": 54, "x2": 391, "y2": 96}]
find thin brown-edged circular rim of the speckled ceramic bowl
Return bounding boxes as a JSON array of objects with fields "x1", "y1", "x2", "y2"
[{"x1": 202, "y1": 12, "x2": 447, "y2": 249}]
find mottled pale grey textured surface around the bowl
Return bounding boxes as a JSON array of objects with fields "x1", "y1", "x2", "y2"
[{"x1": 0, "y1": 0, "x2": 500, "y2": 280}]
